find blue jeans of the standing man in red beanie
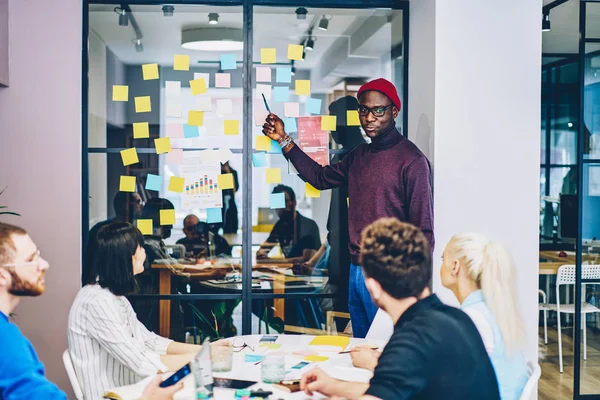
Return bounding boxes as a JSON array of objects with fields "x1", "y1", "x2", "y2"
[{"x1": 348, "y1": 264, "x2": 377, "y2": 338}]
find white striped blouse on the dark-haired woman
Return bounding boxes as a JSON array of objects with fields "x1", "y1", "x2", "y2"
[{"x1": 67, "y1": 285, "x2": 171, "y2": 400}]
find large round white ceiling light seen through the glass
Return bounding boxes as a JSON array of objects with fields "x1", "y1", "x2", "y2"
[{"x1": 181, "y1": 28, "x2": 244, "y2": 51}]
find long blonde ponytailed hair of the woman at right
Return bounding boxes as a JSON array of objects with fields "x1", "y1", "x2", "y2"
[{"x1": 447, "y1": 233, "x2": 525, "y2": 355}]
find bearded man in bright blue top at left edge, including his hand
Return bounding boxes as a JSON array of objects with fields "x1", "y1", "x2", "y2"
[{"x1": 0, "y1": 223, "x2": 183, "y2": 400}]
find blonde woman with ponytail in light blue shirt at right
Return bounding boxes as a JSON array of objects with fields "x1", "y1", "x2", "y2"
[{"x1": 440, "y1": 233, "x2": 528, "y2": 400}]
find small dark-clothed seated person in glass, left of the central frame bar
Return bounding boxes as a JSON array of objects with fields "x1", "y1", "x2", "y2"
[{"x1": 177, "y1": 214, "x2": 231, "y2": 258}]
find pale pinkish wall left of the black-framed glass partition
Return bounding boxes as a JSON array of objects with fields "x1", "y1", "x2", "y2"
[{"x1": 0, "y1": 0, "x2": 81, "y2": 398}]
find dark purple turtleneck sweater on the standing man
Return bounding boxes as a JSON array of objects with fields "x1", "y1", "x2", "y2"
[{"x1": 285, "y1": 125, "x2": 434, "y2": 265}]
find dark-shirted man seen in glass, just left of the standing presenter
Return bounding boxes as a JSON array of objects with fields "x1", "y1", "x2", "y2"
[{"x1": 256, "y1": 185, "x2": 321, "y2": 261}]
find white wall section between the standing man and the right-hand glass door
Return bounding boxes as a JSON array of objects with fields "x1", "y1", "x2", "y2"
[{"x1": 409, "y1": 0, "x2": 542, "y2": 368}]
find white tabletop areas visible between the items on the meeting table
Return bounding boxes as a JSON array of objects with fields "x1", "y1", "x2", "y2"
[{"x1": 108, "y1": 335, "x2": 384, "y2": 400}]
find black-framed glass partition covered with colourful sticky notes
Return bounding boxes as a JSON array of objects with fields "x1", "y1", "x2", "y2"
[{"x1": 83, "y1": 1, "x2": 408, "y2": 342}]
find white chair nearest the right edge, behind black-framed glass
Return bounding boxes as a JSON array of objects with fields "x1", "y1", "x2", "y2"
[{"x1": 543, "y1": 265, "x2": 600, "y2": 374}]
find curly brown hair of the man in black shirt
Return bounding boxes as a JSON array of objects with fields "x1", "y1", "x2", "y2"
[{"x1": 360, "y1": 218, "x2": 431, "y2": 299}]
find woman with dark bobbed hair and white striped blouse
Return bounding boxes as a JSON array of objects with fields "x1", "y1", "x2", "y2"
[{"x1": 68, "y1": 222, "x2": 216, "y2": 399}]
